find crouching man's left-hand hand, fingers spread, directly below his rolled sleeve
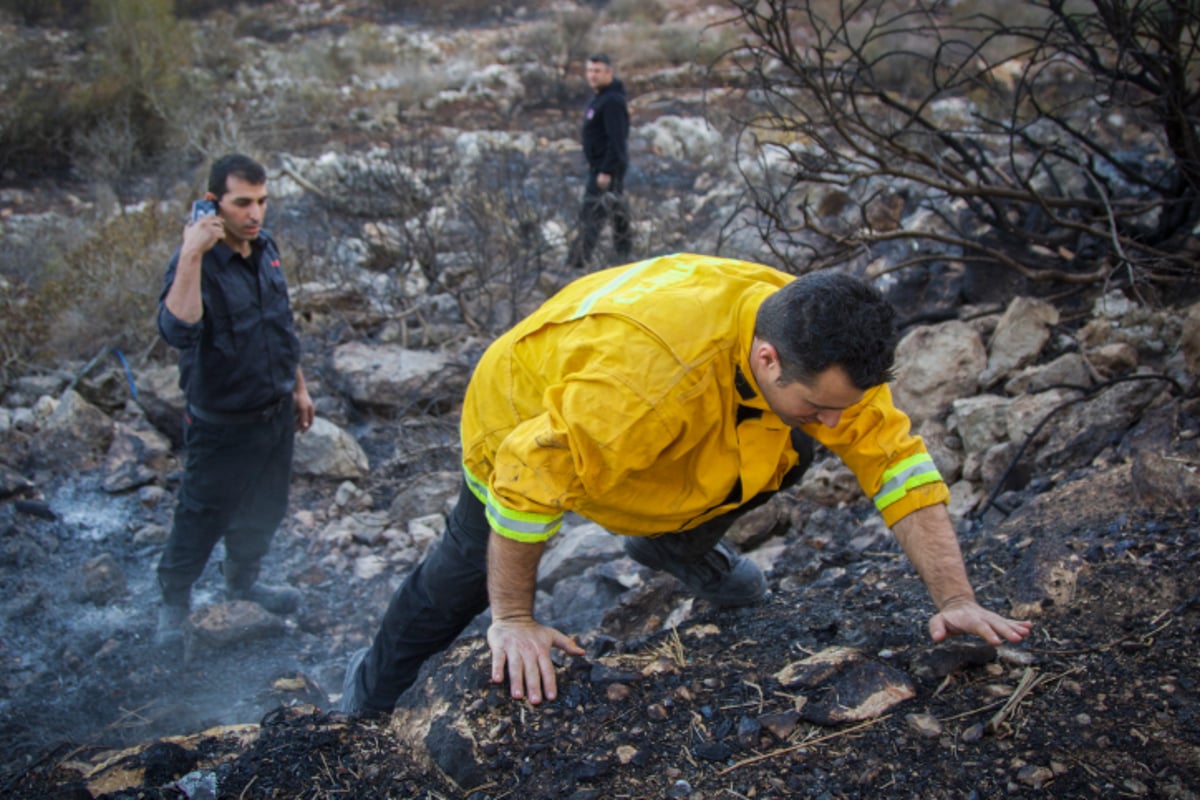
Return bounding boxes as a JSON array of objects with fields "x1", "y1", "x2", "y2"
[{"x1": 487, "y1": 616, "x2": 583, "y2": 705}]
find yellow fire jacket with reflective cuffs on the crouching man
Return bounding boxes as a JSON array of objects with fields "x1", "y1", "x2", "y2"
[{"x1": 462, "y1": 254, "x2": 949, "y2": 542}]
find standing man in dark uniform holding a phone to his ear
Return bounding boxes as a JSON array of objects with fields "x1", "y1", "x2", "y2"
[{"x1": 156, "y1": 155, "x2": 313, "y2": 645}]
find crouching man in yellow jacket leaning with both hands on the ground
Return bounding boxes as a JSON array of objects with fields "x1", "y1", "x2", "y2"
[{"x1": 341, "y1": 254, "x2": 1030, "y2": 714}]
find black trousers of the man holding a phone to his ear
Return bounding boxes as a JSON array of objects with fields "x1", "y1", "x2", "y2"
[{"x1": 158, "y1": 395, "x2": 295, "y2": 606}]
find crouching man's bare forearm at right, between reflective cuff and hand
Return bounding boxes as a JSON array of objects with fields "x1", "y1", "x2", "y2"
[{"x1": 892, "y1": 505, "x2": 974, "y2": 609}]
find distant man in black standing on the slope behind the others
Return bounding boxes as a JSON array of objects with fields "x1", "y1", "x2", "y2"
[{"x1": 569, "y1": 53, "x2": 634, "y2": 270}]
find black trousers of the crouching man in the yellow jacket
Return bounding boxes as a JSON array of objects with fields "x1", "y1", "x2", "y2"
[{"x1": 355, "y1": 431, "x2": 812, "y2": 712}]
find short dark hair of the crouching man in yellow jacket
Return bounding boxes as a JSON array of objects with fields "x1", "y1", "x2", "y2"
[{"x1": 755, "y1": 271, "x2": 898, "y2": 391}]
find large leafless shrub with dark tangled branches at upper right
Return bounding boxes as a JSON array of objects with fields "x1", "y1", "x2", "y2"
[{"x1": 720, "y1": 0, "x2": 1200, "y2": 293}]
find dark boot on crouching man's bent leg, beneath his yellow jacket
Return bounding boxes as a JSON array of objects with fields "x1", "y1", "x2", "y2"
[{"x1": 625, "y1": 533, "x2": 767, "y2": 606}]
